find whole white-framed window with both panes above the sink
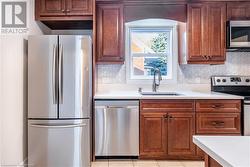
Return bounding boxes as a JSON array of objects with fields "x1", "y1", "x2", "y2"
[{"x1": 126, "y1": 19, "x2": 177, "y2": 83}]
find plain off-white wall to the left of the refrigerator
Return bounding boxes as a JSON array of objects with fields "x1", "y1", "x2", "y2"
[{"x1": 0, "y1": 0, "x2": 50, "y2": 166}]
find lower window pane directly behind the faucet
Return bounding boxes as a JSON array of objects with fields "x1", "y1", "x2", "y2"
[{"x1": 132, "y1": 56, "x2": 167, "y2": 78}]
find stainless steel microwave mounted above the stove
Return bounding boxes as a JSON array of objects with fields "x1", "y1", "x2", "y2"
[{"x1": 227, "y1": 20, "x2": 250, "y2": 49}]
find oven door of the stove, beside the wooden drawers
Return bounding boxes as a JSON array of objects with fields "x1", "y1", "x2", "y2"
[{"x1": 244, "y1": 100, "x2": 250, "y2": 136}]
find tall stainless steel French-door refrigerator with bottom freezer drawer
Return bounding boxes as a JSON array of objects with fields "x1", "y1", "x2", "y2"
[{"x1": 28, "y1": 35, "x2": 92, "y2": 167}]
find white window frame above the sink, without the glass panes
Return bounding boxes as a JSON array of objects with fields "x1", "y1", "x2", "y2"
[{"x1": 125, "y1": 19, "x2": 178, "y2": 84}]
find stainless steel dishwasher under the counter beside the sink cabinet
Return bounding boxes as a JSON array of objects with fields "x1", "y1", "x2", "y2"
[{"x1": 95, "y1": 100, "x2": 139, "y2": 157}]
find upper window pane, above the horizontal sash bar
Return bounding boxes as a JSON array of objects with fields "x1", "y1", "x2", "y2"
[{"x1": 131, "y1": 29, "x2": 170, "y2": 53}]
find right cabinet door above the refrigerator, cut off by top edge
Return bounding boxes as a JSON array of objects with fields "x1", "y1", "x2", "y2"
[{"x1": 66, "y1": 0, "x2": 93, "y2": 16}]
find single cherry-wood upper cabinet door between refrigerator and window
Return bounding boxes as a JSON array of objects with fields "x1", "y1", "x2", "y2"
[{"x1": 97, "y1": 3, "x2": 124, "y2": 63}]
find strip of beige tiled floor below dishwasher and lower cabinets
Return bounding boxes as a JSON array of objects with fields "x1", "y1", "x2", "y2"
[{"x1": 92, "y1": 160, "x2": 205, "y2": 167}]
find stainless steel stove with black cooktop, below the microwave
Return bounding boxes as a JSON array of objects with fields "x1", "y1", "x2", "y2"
[{"x1": 211, "y1": 76, "x2": 250, "y2": 136}]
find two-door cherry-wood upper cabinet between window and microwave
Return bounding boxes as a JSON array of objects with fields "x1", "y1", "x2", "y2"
[{"x1": 187, "y1": 3, "x2": 226, "y2": 64}]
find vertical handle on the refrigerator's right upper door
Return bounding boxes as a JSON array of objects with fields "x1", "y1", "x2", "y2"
[{"x1": 59, "y1": 44, "x2": 63, "y2": 104}]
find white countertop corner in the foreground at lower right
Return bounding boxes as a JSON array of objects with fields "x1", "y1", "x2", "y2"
[{"x1": 193, "y1": 136, "x2": 250, "y2": 167}]
